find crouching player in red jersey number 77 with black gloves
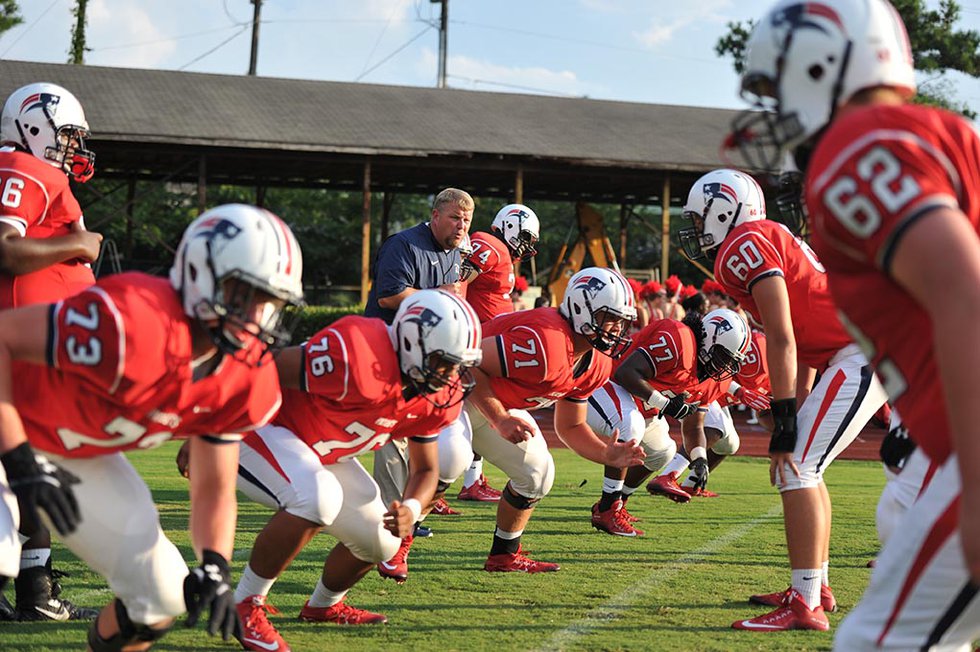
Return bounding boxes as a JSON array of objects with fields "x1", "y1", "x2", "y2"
[{"x1": 588, "y1": 309, "x2": 749, "y2": 536}]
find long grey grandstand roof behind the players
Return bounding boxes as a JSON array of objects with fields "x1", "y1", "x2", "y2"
[{"x1": 0, "y1": 61, "x2": 734, "y2": 203}]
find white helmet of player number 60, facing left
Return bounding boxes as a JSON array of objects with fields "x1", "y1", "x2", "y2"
[{"x1": 677, "y1": 168, "x2": 766, "y2": 259}]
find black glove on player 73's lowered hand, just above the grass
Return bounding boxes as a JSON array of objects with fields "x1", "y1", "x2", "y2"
[{"x1": 184, "y1": 550, "x2": 242, "y2": 641}]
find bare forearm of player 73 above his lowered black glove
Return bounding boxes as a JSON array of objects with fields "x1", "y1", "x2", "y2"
[{"x1": 190, "y1": 437, "x2": 238, "y2": 559}]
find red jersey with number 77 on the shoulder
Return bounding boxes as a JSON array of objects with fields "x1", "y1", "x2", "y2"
[{"x1": 615, "y1": 319, "x2": 730, "y2": 419}]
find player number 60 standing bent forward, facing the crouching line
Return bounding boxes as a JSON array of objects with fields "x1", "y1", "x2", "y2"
[{"x1": 680, "y1": 169, "x2": 885, "y2": 632}]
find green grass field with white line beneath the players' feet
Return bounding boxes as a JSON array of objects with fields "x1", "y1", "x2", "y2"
[{"x1": 0, "y1": 444, "x2": 884, "y2": 652}]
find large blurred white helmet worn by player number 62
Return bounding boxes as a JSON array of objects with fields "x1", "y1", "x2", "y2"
[{"x1": 732, "y1": 0, "x2": 915, "y2": 170}]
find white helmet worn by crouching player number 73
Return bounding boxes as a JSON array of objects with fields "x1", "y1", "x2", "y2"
[{"x1": 170, "y1": 204, "x2": 303, "y2": 359}]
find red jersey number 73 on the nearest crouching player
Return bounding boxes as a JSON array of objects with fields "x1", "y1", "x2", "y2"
[{"x1": 13, "y1": 272, "x2": 281, "y2": 457}]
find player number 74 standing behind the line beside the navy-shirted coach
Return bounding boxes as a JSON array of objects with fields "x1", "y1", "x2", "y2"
[{"x1": 458, "y1": 204, "x2": 541, "y2": 502}]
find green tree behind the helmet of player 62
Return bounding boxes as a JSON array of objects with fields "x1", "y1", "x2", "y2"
[{"x1": 715, "y1": 0, "x2": 980, "y2": 119}]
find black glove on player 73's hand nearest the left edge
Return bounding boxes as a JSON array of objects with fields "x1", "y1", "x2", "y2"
[{"x1": 0, "y1": 442, "x2": 82, "y2": 536}]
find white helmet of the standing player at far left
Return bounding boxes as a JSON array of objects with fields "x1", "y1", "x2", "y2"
[{"x1": 0, "y1": 82, "x2": 95, "y2": 183}]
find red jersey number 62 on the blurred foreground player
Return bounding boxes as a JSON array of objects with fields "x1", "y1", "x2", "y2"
[{"x1": 806, "y1": 105, "x2": 980, "y2": 463}]
